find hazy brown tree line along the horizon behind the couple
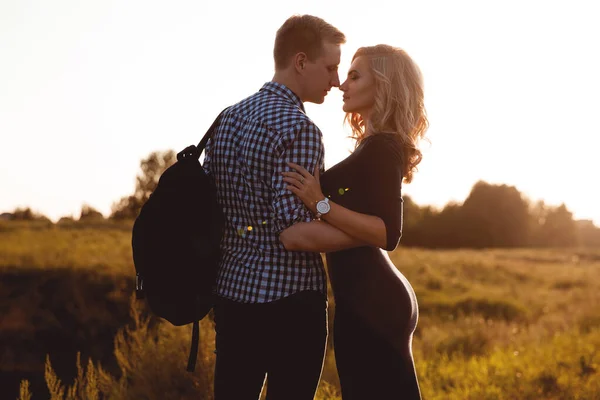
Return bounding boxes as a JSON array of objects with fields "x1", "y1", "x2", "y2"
[{"x1": 3, "y1": 150, "x2": 600, "y2": 248}]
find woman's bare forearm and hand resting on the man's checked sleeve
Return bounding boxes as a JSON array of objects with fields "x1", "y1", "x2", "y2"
[{"x1": 283, "y1": 163, "x2": 387, "y2": 249}]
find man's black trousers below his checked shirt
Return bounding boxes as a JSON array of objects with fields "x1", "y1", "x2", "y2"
[{"x1": 214, "y1": 291, "x2": 327, "y2": 400}]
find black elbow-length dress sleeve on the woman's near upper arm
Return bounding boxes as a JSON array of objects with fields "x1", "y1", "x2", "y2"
[{"x1": 361, "y1": 137, "x2": 403, "y2": 251}]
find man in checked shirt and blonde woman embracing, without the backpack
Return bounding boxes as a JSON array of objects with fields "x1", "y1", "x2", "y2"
[{"x1": 203, "y1": 15, "x2": 428, "y2": 400}]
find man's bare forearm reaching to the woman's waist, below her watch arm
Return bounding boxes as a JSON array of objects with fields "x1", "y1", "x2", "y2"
[{"x1": 279, "y1": 221, "x2": 368, "y2": 253}]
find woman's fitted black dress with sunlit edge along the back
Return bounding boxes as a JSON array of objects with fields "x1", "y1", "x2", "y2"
[{"x1": 321, "y1": 134, "x2": 421, "y2": 400}]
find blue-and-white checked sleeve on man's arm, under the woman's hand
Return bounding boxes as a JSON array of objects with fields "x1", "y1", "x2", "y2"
[{"x1": 271, "y1": 121, "x2": 324, "y2": 233}]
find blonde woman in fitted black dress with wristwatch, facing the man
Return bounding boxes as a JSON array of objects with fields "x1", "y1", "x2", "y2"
[{"x1": 280, "y1": 45, "x2": 428, "y2": 400}]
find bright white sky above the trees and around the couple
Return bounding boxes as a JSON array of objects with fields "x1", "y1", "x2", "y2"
[{"x1": 0, "y1": 0, "x2": 600, "y2": 226}]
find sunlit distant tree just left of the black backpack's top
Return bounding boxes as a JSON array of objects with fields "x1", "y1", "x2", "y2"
[{"x1": 110, "y1": 150, "x2": 177, "y2": 219}]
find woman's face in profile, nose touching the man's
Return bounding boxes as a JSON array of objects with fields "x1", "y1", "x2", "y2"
[{"x1": 340, "y1": 56, "x2": 375, "y2": 119}]
